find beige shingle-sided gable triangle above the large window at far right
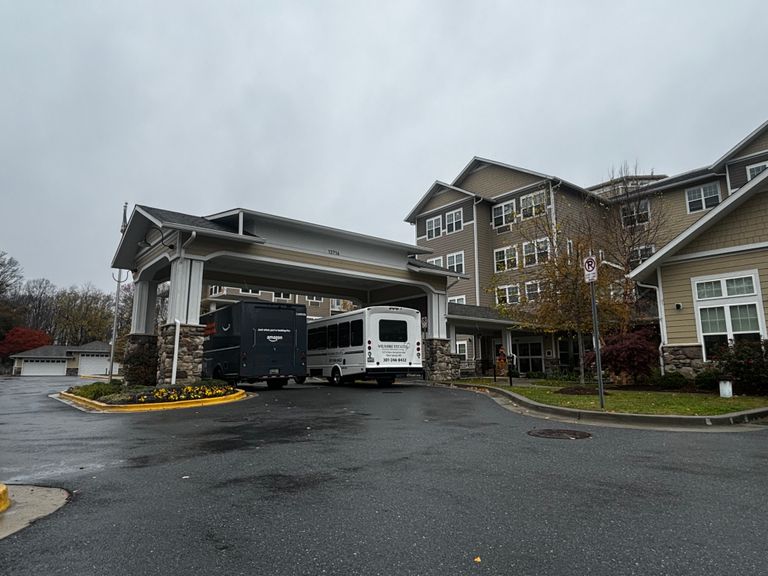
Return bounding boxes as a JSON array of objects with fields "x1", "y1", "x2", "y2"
[{"x1": 680, "y1": 193, "x2": 768, "y2": 254}]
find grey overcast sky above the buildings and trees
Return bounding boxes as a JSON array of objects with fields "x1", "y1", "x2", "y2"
[{"x1": 0, "y1": 0, "x2": 768, "y2": 289}]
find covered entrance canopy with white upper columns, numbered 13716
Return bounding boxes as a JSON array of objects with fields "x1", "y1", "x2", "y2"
[{"x1": 112, "y1": 205, "x2": 465, "y2": 384}]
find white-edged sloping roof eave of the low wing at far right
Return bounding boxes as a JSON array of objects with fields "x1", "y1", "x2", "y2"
[{"x1": 629, "y1": 170, "x2": 768, "y2": 280}]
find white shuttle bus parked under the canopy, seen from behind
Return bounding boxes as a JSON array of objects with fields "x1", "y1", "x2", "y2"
[{"x1": 307, "y1": 306, "x2": 424, "y2": 386}]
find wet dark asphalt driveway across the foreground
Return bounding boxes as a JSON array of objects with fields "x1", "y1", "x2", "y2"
[{"x1": 0, "y1": 377, "x2": 768, "y2": 576}]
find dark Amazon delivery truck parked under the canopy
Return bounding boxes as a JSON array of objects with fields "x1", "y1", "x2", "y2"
[{"x1": 200, "y1": 302, "x2": 307, "y2": 389}]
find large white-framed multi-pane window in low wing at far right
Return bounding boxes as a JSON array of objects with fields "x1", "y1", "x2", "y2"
[{"x1": 692, "y1": 271, "x2": 765, "y2": 360}]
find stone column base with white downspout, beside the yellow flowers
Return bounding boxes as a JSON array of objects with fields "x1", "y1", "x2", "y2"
[{"x1": 157, "y1": 324, "x2": 205, "y2": 387}]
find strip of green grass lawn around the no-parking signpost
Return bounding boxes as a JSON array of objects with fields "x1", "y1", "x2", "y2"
[{"x1": 492, "y1": 386, "x2": 768, "y2": 416}]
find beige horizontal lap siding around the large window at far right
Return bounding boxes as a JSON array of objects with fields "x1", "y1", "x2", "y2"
[{"x1": 661, "y1": 250, "x2": 768, "y2": 344}]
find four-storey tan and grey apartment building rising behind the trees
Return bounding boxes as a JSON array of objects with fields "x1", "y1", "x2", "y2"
[{"x1": 405, "y1": 119, "x2": 768, "y2": 372}]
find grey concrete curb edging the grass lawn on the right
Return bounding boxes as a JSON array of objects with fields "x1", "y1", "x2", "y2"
[{"x1": 446, "y1": 382, "x2": 768, "y2": 428}]
